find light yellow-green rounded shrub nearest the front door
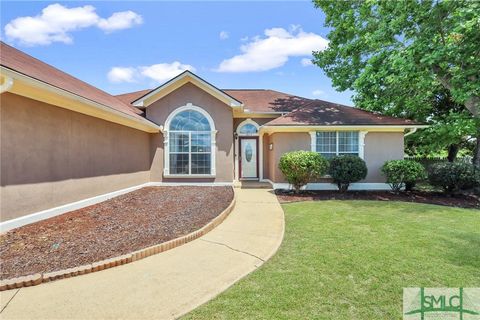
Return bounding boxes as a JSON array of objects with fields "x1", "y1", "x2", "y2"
[{"x1": 278, "y1": 151, "x2": 328, "y2": 192}]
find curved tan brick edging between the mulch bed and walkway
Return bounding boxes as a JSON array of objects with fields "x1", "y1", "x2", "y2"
[{"x1": 0, "y1": 190, "x2": 236, "y2": 291}]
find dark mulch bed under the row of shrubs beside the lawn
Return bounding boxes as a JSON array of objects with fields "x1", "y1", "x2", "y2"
[{"x1": 275, "y1": 190, "x2": 480, "y2": 209}]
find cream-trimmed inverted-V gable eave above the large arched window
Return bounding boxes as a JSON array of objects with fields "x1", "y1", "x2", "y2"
[{"x1": 132, "y1": 70, "x2": 243, "y2": 108}]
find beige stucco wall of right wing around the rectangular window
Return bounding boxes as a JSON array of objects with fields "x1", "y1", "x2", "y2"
[{"x1": 267, "y1": 132, "x2": 404, "y2": 183}]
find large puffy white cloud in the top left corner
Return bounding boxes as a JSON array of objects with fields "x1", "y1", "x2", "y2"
[{"x1": 4, "y1": 3, "x2": 142, "y2": 46}]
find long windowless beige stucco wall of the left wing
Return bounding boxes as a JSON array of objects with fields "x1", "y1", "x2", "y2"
[{"x1": 0, "y1": 93, "x2": 150, "y2": 221}]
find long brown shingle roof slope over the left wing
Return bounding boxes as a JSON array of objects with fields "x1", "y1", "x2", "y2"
[{"x1": 0, "y1": 41, "x2": 145, "y2": 121}]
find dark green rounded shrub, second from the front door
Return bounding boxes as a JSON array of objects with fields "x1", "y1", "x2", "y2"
[{"x1": 329, "y1": 156, "x2": 368, "y2": 192}]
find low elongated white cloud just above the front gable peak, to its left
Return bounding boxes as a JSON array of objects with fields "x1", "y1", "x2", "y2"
[{"x1": 107, "y1": 61, "x2": 195, "y2": 83}]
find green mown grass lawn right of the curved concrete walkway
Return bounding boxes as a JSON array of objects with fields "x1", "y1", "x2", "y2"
[{"x1": 186, "y1": 201, "x2": 480, "y2": 319}]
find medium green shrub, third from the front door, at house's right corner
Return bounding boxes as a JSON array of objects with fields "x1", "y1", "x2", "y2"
[{"x1": 382, "y1": 160, "x2": 427, "y2": 192}]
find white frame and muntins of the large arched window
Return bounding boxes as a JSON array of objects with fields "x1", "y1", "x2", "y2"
[{"x1": 163, "y1": 103, "x2": 217, "y2": 178}]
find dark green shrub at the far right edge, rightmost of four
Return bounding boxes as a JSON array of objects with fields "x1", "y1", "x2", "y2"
[{"x1": 428, "y1": 162, "x2": 480, "y2": 193}]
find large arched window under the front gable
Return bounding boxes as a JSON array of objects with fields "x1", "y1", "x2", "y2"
[{"x1": 165, "y1": 105, "x2": 215, "y2": 175}]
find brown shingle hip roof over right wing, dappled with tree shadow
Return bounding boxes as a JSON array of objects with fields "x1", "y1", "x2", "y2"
[{"x1": 265, "y1": 100, "x2": 419, "y2": 126}]
